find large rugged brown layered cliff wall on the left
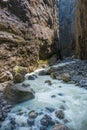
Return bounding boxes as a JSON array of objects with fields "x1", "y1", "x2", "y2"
[{"x1": 0, "y1": 0, "x2": 58, "y2": 72}]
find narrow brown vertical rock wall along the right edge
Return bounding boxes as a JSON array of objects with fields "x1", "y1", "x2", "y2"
[{"x1": 76, "y1": 0, "x2": 87, "y2": 59}]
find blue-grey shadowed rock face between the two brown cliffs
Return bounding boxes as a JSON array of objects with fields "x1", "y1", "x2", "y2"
[{"x1": 59, "y1": 0, "x2": 77, "y2": 56}]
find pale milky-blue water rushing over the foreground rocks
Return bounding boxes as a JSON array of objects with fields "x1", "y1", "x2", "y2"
[{"x1": 0, "y1": 61, "x2": 87, "y2": 130}]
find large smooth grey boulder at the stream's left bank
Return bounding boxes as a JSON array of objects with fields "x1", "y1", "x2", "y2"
[{"x1": 5, "y1": 84, "x2": 35, "y2": 103}]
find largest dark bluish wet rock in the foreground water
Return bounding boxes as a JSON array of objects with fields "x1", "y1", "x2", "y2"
[{"x1": 40, "y1": 115, "x2": 55, "y2": 127}]
